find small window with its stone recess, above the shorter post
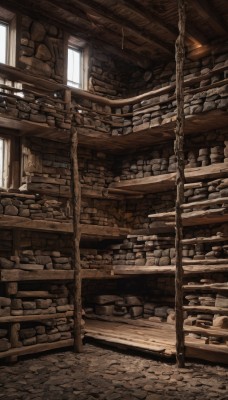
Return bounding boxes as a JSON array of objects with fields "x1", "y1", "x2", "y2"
[{"x1": 67, "y1": 36, "x2": 88, "y2": 89}]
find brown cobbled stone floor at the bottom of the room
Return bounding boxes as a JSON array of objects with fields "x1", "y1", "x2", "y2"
[{"x1": 0, "y1": 344, "x2": 228, "y2": 400}]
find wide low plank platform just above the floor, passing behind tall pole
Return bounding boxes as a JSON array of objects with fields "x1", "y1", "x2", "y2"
[{"x1": 85, "y1": 316, "x2": 228, "y2": 364}]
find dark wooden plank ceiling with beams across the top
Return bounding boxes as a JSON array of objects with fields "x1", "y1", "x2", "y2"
[{"x1": 1, "y1": 0, "x2": 228, "y2": 68}]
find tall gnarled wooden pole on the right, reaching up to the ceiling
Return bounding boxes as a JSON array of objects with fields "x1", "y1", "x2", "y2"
[{"x1": 174, "y1": 0, "x2": 186, "y2": 368}]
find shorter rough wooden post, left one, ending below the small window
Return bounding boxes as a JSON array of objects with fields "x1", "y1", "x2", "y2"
[{"x1": 70, "y1": 128, "x2": 82, "y2": 353}]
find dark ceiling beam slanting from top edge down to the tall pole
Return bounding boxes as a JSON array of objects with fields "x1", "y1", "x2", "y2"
[{"x1": 71, "y1": 0, "x2": 174, "y2": 56}]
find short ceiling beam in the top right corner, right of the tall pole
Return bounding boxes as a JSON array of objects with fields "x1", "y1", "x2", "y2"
[{"x1": 191, "y1": 0, "x2": 228, "y2": 36}]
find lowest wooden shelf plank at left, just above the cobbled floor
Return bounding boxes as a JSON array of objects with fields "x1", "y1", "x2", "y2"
[{"x1": 0, "y1": 339, "x2": 74, "y2": 358}]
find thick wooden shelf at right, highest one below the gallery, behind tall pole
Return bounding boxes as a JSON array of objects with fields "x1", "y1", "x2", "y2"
[{"x1": 110, "y1": 162, "x2": 228, "y2": 193}]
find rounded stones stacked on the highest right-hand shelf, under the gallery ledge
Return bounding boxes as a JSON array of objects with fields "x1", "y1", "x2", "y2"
[{"x1": 115, "y1": 129, "x2": 228, "y2": 182}]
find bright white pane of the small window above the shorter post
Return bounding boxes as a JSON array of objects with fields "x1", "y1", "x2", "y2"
[{"x1": 67, "y1": 48, "x2": 81, "y2": 87}]
